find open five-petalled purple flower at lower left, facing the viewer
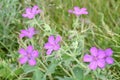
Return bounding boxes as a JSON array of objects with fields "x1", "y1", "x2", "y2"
[{"x1": 18, "y1": 45, "x2": 39, "y2": 66}]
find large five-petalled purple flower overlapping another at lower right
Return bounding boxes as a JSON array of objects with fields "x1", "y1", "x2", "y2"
[{"x1": 83, "y1": 47, "x2": 106, "y2": 70}]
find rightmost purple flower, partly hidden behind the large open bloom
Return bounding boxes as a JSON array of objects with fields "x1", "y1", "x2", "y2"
[{"x1": 105, "y1": 48, "x2": 114, "y2": 64}]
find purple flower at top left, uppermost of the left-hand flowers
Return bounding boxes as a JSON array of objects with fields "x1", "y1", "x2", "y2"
[{"x1": 22, "y1": 5, "x2": 42, "y2": 19}]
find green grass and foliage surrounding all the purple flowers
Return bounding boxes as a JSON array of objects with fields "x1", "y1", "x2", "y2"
[{"x1": 0, "y1": 0, "x2": 120, "y2": 80}]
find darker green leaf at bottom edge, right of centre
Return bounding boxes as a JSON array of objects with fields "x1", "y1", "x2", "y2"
[{"x1": 73, "y1": 67, "x2": 84, "y2": 80}]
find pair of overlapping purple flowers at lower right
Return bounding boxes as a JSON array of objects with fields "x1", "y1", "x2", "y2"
[{"x1": 83, "y1": 47, "x2": 114, "y2": 70}]
